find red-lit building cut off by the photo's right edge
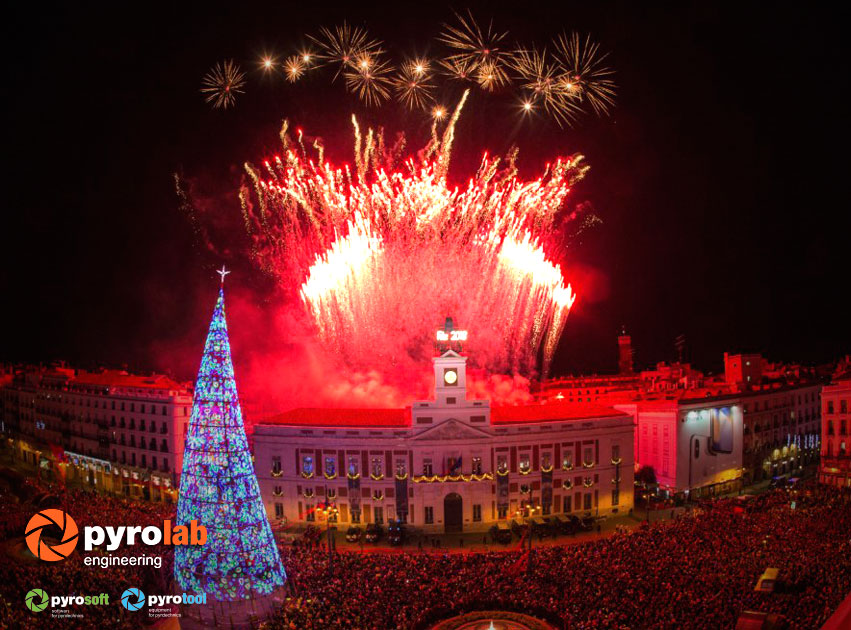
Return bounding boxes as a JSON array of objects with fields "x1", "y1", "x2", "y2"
[{"x1": 819, "y1": 359, "x2": 851, "y2": 488}]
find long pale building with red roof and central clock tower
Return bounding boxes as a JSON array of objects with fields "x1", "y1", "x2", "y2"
[{"x1": 254, "y1": 331, "x2": 633, "y2": 532}]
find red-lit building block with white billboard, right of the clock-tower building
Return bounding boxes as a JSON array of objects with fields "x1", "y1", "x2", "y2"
[{"x1": 540, "y1": 344, "x2": 822, "y2": 495}]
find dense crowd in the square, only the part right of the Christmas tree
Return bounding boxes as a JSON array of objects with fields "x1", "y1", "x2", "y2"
[{"x1": 269, "y1": 487, "x2": 851, "y2": 630}]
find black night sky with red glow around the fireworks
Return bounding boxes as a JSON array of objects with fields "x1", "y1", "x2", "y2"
[{"x1": 0, "y1": 2, "x2": 851, "y2": 378}]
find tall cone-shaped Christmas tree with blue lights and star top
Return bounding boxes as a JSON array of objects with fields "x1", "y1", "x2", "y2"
[{"x1": 174, "y1": 267, "x2": 286, "y2": 601}]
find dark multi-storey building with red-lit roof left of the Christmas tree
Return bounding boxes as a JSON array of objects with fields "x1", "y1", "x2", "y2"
[{"x1": 0, "y1": 367, "x2": 192, "y2": 501}]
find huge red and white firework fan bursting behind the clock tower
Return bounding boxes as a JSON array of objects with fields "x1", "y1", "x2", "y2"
[{"x1": 241, "y1": 95, "x2": 586, "y2": 374}]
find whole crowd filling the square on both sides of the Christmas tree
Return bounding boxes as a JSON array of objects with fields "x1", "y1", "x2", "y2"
[{"x1": 0, "y1": 476, "x2": 851, "y2": 630}]
